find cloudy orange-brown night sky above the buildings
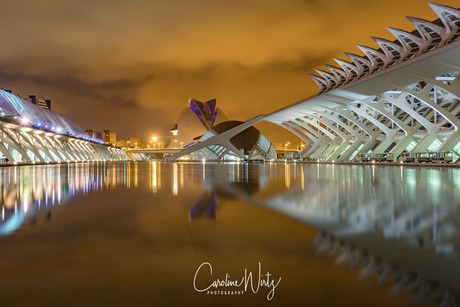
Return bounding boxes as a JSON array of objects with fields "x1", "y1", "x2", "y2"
[{"x1": 0, "y1": 0, "x2": 459, "y2": 142}]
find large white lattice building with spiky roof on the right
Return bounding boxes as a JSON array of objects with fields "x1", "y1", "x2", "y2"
[{"x1": 265, "y1": 4, "x2": 460, "y2": 161}]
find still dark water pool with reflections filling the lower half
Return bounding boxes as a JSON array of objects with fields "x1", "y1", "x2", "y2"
[{"x1": 0, "y1": 162, "x2": 460, "y2": 306}]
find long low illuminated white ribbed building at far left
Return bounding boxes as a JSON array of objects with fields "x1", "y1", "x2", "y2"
[{"x1": 0, "y1": 90, "x2": 128, "y2": 163}]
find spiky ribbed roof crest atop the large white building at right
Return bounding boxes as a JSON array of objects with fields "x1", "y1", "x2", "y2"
[{"x1": 309, "y1": 3, "x2": 460, "y2": 94}]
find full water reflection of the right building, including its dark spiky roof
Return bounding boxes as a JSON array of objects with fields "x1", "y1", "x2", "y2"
[{"x1": 239, "y1": 165, "x2": 460, "y2": 306}]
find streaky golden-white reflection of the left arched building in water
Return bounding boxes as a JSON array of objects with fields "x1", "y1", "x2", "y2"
[{"x1": 0, "y1": 162, "x2": 135, "y2": 235}]
